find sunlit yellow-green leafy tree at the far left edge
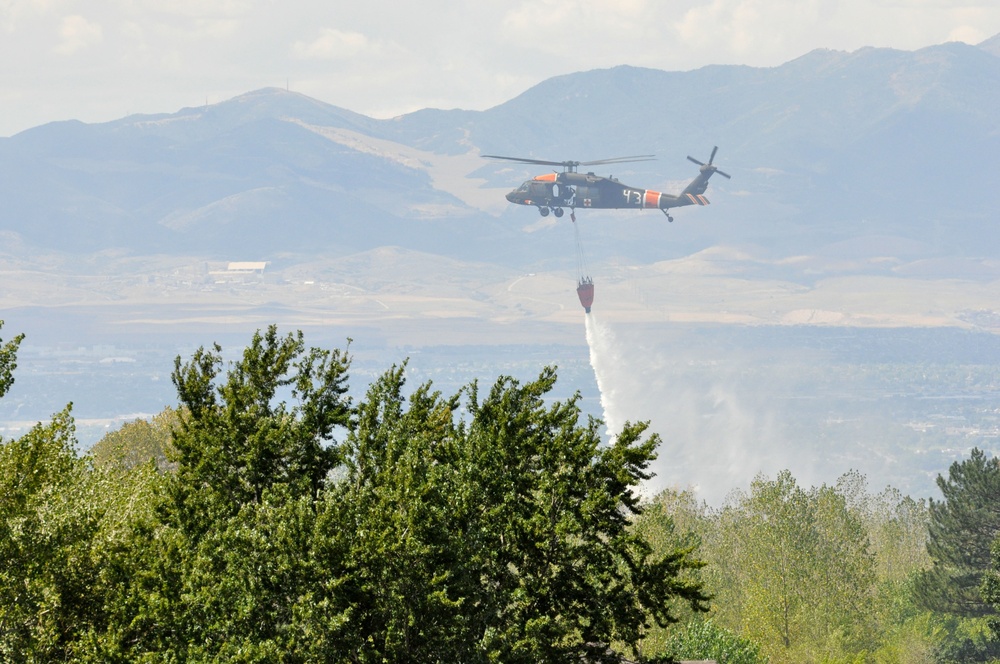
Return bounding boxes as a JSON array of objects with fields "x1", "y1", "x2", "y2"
[{"x1": 0, "y1": 340, "x2": 166, "y2": 662}]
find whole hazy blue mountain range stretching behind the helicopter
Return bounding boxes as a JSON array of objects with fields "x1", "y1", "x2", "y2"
[{"x1": 0, "y1": 36, "x2": 1000, "y2": 265}]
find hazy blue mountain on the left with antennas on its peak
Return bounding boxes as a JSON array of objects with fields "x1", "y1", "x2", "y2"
[{"x1": 0, "y1": 90, "x2": 516, "y2": 255}]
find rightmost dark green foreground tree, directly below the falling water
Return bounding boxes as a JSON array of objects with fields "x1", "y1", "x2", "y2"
[{"x1": 464, "y1": 369, "x2": 707, "y2": 661}]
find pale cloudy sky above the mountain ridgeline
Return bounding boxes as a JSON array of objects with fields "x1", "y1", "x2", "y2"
[{"x1": 0, "y1": 0, "x2": 1000, "y2": 136}]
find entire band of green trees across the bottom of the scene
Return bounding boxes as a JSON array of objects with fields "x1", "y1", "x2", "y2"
[{"x1": 11, "y1": 320, "x2": 1000, "y2": 664}]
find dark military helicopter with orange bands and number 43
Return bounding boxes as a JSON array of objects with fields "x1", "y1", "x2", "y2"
[{"x1": 483, "y1": 146, "x2": 731, "y2": 221}]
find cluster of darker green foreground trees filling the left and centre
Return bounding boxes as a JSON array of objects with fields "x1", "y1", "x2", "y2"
[{"x1": 0, "y1": 327, "x2": 707, "y2": 662}]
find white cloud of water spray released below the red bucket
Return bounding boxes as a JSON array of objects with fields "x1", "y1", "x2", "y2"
[{"x1": 586, "y1": 312, "x2": 832, "y2": 505}]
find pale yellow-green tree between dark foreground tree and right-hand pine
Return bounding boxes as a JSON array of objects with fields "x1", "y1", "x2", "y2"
[{"x1": 709, "y1": 471, "x2": 875, "y2": 661}]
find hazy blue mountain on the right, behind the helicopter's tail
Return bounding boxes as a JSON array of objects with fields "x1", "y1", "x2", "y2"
[{"x1": 379, "y1": 43, "x2": 1000, "y2": 255}]
